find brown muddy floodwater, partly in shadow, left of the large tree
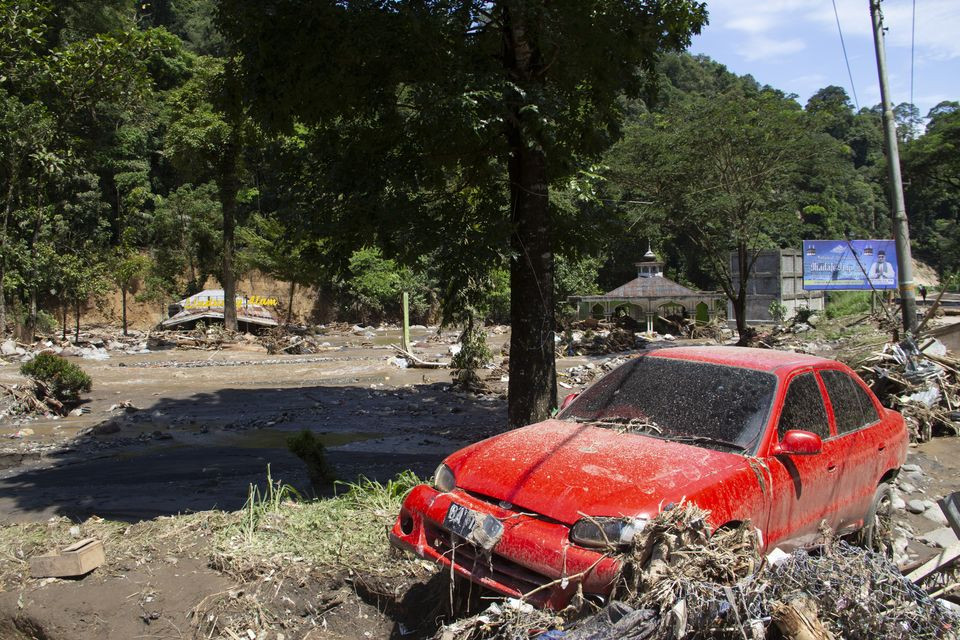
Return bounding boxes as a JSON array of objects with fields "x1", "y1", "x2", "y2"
[{"x1": 0, "y1": 330, "x2": 505, "y2": 521}]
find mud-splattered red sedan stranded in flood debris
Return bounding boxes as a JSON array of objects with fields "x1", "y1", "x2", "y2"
[{"x1": 390, "y1": 347, "x2": 908, "y2": 608}]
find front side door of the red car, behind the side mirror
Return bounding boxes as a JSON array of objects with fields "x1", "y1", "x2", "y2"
[{"x1": 765, "y1": 369, "x2": 841, "y2": 548}]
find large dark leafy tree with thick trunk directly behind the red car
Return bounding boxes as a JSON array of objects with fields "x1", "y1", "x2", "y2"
[{"x1": 220, "y1": 0, "x2": 706, "y2": 425}]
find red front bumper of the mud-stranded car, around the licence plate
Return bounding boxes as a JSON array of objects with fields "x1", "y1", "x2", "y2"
[{"x1": 390, "y1": 485, "x2": 620, "y2": 609}]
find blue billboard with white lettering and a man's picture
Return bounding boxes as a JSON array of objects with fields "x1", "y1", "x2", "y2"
[{"x1": 803, "y1": 240, "x2": 897, "y2": 291}]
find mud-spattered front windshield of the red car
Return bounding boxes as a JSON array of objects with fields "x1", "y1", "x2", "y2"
[{"x1": 560, "y1": 356, "x2": 777, "y2": 453}]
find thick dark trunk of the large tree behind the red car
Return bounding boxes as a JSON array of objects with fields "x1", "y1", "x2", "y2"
[{"x1": 503, "y1": 4, "x2": 557, "y2": 427}]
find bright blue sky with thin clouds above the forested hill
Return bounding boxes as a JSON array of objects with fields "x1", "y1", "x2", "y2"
[{"x1": 690, "y1": 0, "x2": 960, "y2": 117}]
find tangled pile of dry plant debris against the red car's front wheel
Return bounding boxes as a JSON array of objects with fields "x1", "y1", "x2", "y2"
[{"x1": 434, "y1": 503, "x2": 960, "y2": 640}]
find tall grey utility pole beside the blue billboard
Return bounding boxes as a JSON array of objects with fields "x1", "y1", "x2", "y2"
[{"x1": 869, "y1": 0, "x2": 917, "y2": 333}]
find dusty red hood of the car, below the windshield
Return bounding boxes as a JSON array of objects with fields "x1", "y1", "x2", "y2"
[{"x1": 446, "y1": 420, "x2": 747, "y2": 524}]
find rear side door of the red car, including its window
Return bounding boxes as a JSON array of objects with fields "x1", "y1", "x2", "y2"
[{"x1": 819, "y1": 369, "x2": 880, "y2": 533}]
